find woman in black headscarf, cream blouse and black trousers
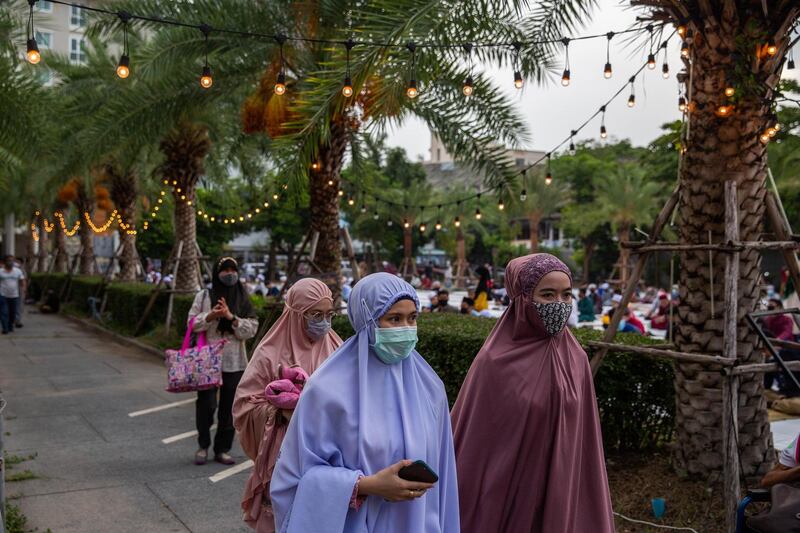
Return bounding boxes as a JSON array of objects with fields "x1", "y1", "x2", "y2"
[{"x1": 188, "y1": 257, "x2": 258, "y2": 465}]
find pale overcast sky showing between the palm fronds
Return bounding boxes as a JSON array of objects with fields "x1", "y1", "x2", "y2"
[{"x1": 387, "y1": 0, "x2": 800, "y2": 160}]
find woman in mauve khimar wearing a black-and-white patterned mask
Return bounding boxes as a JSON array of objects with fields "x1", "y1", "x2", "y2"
[{"x1": 452, "y1": 254, "x2": 614, "y2": 533}]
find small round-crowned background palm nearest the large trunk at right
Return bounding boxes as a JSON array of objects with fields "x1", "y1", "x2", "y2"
[{"x1": 593, "y1": 164, "x2": 664, "y2": 287}]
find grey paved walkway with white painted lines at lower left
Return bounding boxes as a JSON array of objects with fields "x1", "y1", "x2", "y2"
[{"x1": 0, "y1": 314, "x2": 251, "y2": 533}]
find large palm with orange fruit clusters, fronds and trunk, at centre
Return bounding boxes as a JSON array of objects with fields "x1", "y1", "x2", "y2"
[{"x1": 87, "y1": 0, "x2": 594, "y2": 296}]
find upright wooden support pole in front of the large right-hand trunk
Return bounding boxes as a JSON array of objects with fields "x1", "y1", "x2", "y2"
[{"x1": 722, "y1": 180, "x2": 741, "y2": 533}]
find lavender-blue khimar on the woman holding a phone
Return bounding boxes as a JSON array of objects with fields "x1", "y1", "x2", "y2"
[{"x1": 270, "y1": 273, "x2": 460, "y2": 533}]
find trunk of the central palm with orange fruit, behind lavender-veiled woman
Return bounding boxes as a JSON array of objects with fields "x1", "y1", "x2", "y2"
[{"x1": 309, "y1": 119, "x2": 347, "y2": 300}]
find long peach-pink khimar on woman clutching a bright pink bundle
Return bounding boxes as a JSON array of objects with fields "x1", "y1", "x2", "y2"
[{"x1": 233, "y1": 278, "x2": 342, "y2": 533}]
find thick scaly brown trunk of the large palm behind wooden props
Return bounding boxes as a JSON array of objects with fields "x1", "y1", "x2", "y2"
[{"x1": 675, "y1": 23, "x2": 775, "y2": 476}]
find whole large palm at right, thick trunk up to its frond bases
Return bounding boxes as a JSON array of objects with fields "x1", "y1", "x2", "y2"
[{"x1": 631, "y1": 0, "x2": 800, "y2": 475}]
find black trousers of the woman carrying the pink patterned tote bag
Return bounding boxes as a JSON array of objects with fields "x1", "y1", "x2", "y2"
[{"x1": 195, "y1": 371, "x2": 244, "y2": 454}]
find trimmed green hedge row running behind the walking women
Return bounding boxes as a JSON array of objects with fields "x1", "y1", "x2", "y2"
[{"x1": 30, "y1": 274, "x2": 675, "y2": 449}]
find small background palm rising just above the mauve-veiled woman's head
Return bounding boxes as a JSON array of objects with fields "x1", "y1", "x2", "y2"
[{"x1": 514, "y1": 169, "x2": 570, "y2": 253}]
